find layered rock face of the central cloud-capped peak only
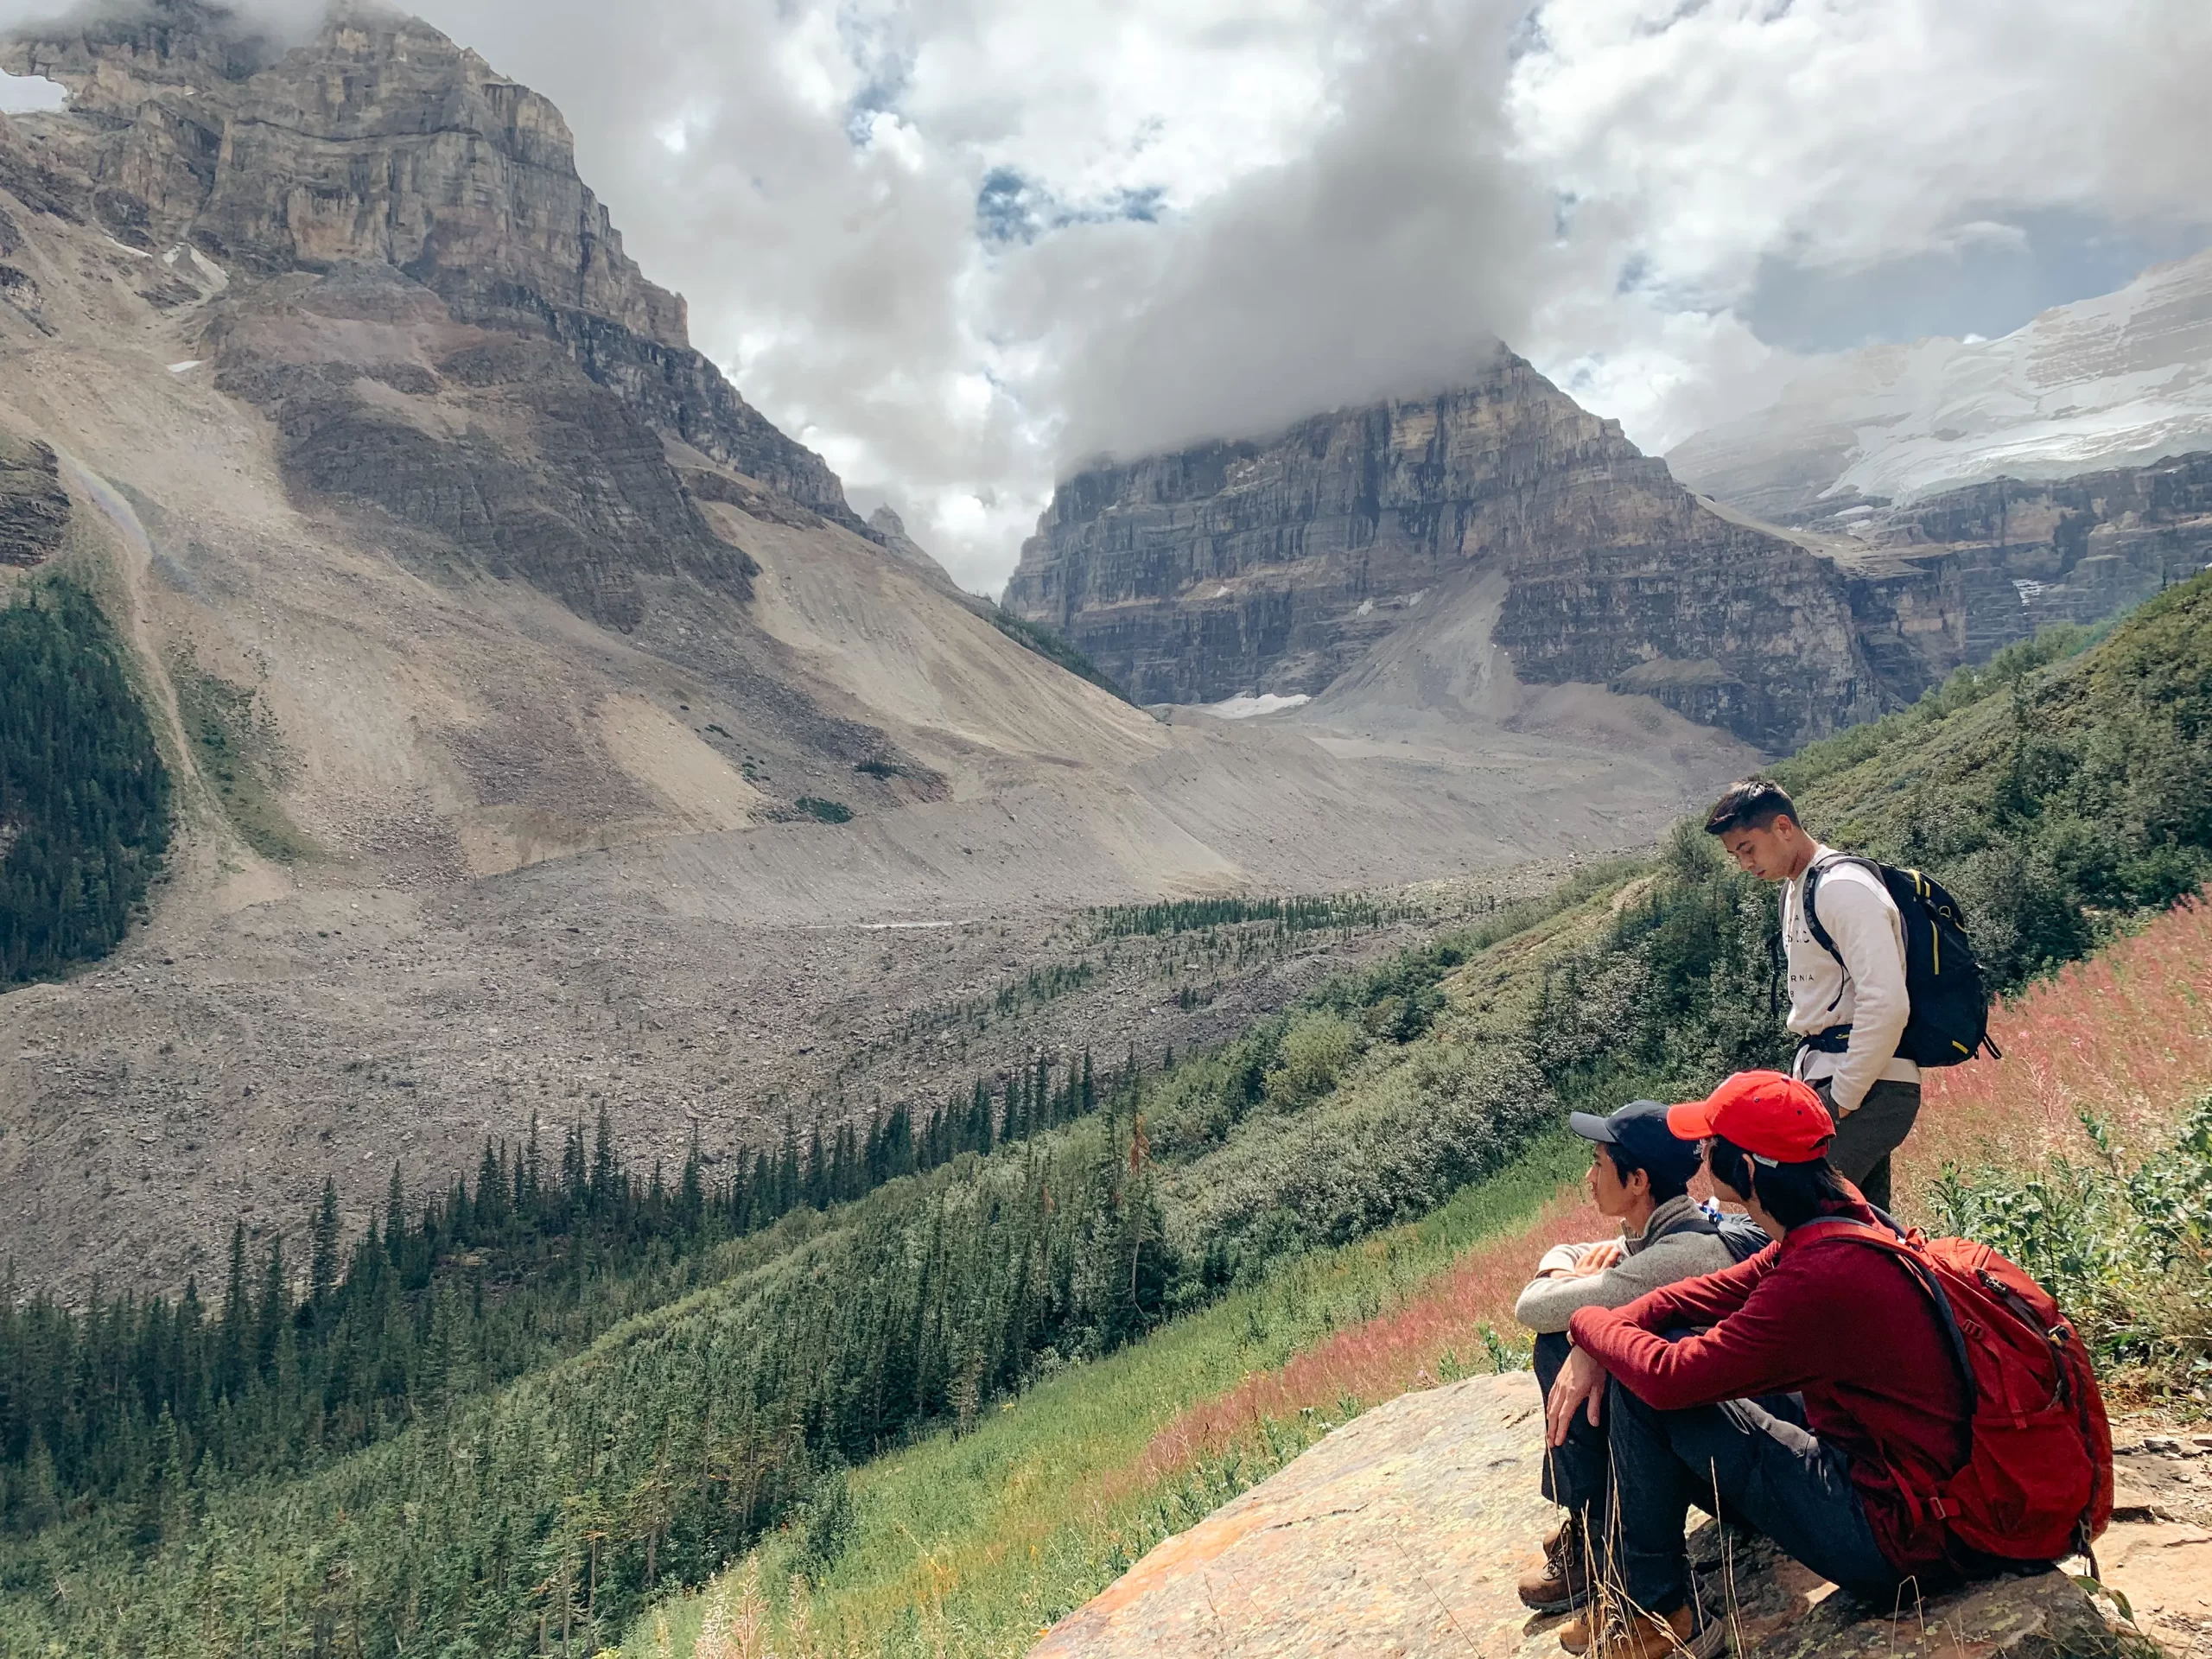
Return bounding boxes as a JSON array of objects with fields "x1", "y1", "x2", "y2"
[{"x1": 1007, "y1": 354, "x2": 1885, "y2": 747}]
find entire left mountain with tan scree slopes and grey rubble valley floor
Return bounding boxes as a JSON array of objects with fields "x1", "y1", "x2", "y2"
[{"x1": 0, "y1": 0, "x2": 1750, "y2": 1287}]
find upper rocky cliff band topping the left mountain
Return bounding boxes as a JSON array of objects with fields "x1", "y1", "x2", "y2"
[{"x1": 0, "y1": 0, "x2": 868, "y2": 533}]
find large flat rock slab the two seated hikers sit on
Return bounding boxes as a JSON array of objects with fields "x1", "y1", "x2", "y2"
[{"x1": 1031, "y1": 1374, "x2": 2141, "y2": 1659}]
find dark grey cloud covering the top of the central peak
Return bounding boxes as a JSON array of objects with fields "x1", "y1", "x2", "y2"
[{"x1": 1018, "y1": 4, "x2": 1553, "y2": 458}]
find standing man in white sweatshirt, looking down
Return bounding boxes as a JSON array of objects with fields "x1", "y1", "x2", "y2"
[{"x1": 1706, "y1": 779, "x2": 1920, "y2": 1210}]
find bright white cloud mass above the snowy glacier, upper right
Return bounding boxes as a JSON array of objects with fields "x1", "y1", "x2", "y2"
[{"x1": 1509, "y1": 0, "x2": 2212, "y2": 449}]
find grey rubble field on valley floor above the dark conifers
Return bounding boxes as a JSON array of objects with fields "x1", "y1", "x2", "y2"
[{"x1": 0, "y1": 868, "x2": 1557, "y2": 1294}]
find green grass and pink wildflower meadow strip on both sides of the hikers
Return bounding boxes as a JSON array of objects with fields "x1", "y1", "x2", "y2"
[{"x1": 645, "y1": 905, "x2": 2212, "y2": 1659}]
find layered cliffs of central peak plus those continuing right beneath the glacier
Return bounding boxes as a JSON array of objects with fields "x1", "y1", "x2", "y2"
[{"x1": 1007, "y1": 356, "x2": 2212, "y2": 750}]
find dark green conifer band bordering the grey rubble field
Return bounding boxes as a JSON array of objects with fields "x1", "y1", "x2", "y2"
[{"x1": 0, "y1": 1053, "x2": 1106, "y2": 1544}]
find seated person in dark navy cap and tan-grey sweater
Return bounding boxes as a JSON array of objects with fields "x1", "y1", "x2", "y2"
[{"x1": 1513, "y1": 1099, "x2": 1734, "y2": 1612}]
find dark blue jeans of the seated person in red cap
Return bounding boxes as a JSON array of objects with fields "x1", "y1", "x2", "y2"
[{"x1": 1606, "y1": 1378, "x2": 1897, "y2": 1615}]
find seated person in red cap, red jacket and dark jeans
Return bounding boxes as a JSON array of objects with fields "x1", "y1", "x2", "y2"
[{"x1": 1546, "y1": 1071, "x2": 1971, "y2": 1659}]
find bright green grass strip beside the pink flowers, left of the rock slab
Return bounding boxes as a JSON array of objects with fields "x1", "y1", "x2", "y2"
[{"x1": 624, "y1": 1137, "x2": 1584, "y2": 1659}]
